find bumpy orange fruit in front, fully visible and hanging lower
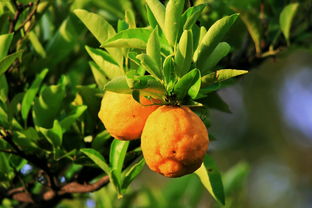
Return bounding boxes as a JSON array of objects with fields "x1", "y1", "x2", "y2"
[{"x1": 141, "y1": 106, "x2": 209, "y2": 177}]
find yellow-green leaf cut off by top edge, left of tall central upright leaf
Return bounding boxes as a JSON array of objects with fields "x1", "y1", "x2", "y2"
[{"x1": 146, "y1": 0, "x2": 166, "y2": 31}]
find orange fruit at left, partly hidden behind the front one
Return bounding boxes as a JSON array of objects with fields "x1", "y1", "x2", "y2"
[{"x1": 98, "y1": 91, "x2": 159, "y2": 140}]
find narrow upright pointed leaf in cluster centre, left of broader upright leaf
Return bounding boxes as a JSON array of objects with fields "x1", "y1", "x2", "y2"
[{"x1": 146, "y1": 27, "x2": 161, "y2": 71}]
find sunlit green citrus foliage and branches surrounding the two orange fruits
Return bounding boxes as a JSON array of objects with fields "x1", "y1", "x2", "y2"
[{"x1": 0, "y1": 0, "x2": 312, "y2": 207}]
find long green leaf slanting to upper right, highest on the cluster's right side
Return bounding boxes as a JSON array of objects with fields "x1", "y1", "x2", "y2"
[{"x1": 193, "y1": 14, "x2": 238, "y2": 70}]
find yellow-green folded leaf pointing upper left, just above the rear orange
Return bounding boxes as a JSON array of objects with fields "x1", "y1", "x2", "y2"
[{"x1": 86, "y1": 46, "x2": 124, "y2": 79}]
